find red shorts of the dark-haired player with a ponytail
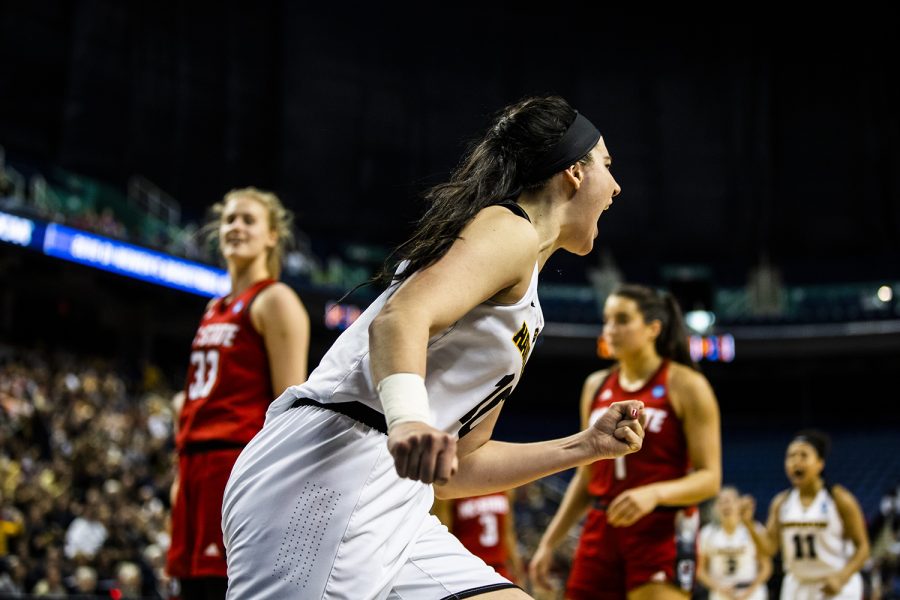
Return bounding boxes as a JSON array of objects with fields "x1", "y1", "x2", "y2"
[{"x1": 566, "y1": 509, "x2": 697, "y2": 600}]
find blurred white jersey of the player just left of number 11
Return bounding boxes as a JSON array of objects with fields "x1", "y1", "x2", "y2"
[{"x1": 700, "y1": 523, "x2": 757, "y2": 586}]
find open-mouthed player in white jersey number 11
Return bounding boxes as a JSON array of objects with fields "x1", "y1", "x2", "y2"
[{"x1": 741, "y1": 429, "x2": 869, "y2": 600}]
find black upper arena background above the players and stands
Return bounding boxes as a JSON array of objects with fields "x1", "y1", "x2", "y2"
[{"x1": 0, "y1": 0, "x2": 900, "y2": 283}]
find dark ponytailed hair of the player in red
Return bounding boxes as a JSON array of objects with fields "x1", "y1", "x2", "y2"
[{"x1": 610, "y1": 283, "x2": 697, "y2": 369}]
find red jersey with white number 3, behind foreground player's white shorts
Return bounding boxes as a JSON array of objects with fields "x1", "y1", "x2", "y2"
[{"x1": 453, "y1": 492, "x2": 511, "y2": 568}]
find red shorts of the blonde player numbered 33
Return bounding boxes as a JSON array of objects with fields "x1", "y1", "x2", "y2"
[{"x1": 166, "y1": 448, "x2": 241, "y2": 579}]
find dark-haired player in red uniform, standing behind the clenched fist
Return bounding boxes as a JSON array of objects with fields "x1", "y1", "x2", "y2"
[{"x1": 530, "y1": 285, "x2": 722, "y2": 600}]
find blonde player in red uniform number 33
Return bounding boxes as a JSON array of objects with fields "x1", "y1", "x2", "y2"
[{"x1": 166, "y1": 187, "x2": 309, "y2": 600}]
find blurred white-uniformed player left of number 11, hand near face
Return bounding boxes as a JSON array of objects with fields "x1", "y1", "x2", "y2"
[{"x1": 697, "y1": 486, "x2": 772, "y2": 600}]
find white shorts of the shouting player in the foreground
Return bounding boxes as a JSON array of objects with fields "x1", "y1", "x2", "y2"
[{"x1": 222, "y1": 397, "x2": 515, "y2": 600}]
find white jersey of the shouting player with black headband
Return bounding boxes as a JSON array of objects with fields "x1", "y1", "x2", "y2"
[{"x1": 282, "y1": 264, "x2": 544, "y2": 437}]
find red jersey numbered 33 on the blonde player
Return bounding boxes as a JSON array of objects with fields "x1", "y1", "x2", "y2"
[{"x1": 176, "y1": 279, "x2": 275, "y2": 451}]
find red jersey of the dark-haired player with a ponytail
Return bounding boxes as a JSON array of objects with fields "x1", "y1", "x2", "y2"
[{"x1": 588, "y1": 360, "x2": 690, "y2": 504}]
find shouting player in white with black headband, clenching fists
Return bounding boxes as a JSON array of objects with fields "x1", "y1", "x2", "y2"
[{"x1": 222, "y1": 96, "x2": 643, "y2": 600}]
